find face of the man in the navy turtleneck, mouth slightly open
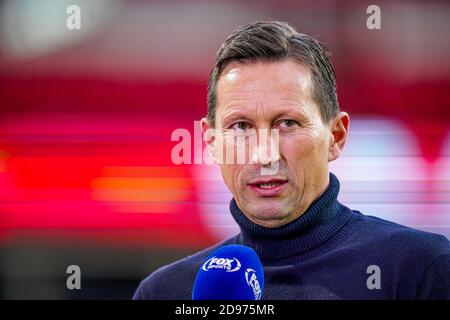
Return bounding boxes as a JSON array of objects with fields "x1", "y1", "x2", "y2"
[{"x1": 202, "y1": 61, "x2": 342, "y2": 228}]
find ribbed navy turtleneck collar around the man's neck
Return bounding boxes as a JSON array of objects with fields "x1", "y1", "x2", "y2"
[{"x1": 230, "y1": 173, "x2": 351, "y2": 260}]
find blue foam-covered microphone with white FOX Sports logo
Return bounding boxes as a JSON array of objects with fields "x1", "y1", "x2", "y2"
[{"x1": 192, "y1": 244, "x2": 264, "y2": 300}]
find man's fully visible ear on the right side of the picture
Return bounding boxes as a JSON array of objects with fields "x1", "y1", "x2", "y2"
[{"x1": 328, "y1": 111, "x2": 350, "y2": 162}]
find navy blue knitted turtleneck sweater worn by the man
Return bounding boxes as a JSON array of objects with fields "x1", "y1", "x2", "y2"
[{"x1": 133, "y1": 174, "x2": 450, "y2": 300}]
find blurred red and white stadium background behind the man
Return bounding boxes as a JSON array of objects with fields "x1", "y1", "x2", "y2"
[{"x1": 0, "y1": 0, "x2": 450, "y2": 298}]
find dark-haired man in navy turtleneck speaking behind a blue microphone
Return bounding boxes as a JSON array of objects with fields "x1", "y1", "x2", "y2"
[{"x1": 134, "y1": 21, "x2": 450, "y2": 299}]
